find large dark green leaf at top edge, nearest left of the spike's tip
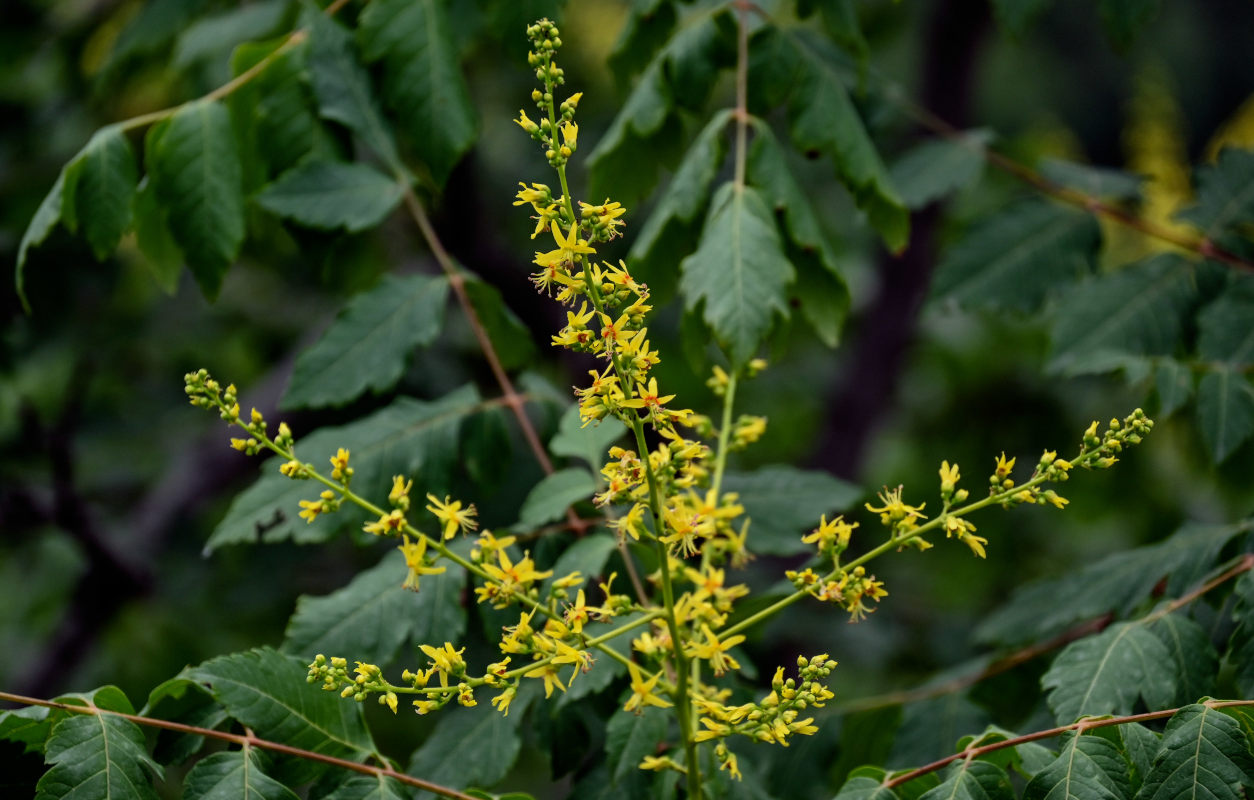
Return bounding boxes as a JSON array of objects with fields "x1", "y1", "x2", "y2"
[{"x1": 357, "y1": 0, "x2": 479, "y2": 186}]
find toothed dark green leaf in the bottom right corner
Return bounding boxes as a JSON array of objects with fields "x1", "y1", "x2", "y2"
[{"x1": 1136, "y1": 705, "x2": 1254, "y2": 800}]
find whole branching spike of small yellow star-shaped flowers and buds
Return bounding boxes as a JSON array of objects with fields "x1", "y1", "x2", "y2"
[{"x1": 186, "y1": 20, "x2": 1154, "y2": 797}]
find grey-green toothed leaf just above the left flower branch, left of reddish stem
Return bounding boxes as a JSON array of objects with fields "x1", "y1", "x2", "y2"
[{"x1": 280, "y1": 275, "x2": 449, "y2": 409}]
